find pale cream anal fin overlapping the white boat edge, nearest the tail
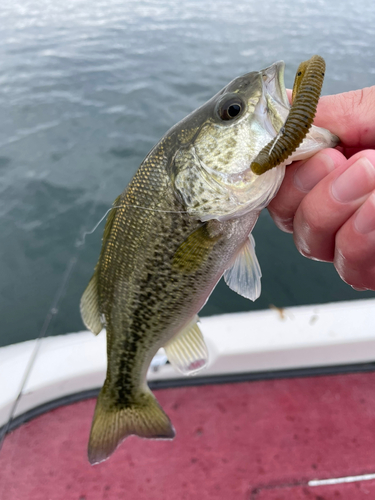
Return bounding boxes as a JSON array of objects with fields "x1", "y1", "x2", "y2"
[{"x1": 164, "y1": 316, "x2": 208, "y2": 375}]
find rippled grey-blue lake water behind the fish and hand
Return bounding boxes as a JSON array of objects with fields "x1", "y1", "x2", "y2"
[{"x1": 0, "y1": 0, "x2": 375, "y2": 345}]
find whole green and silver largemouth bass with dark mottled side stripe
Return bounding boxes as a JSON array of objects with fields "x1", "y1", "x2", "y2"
[{"x1": 80, "y1": 61, "x2": 337, "y2": 464}]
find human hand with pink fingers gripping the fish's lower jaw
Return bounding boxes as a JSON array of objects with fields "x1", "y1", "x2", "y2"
[{"x1": 268, "y1": 87, "x2": 375, "y2": 290}]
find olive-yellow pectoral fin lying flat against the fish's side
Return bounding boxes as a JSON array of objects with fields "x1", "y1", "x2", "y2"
[{"x1": 172, "y1": 221, "x2": 221, "y2": 274}]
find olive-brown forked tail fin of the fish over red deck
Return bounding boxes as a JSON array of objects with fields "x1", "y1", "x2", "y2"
[{"x1": 88, "y1": 385, "x2": 175, "y2": 465}]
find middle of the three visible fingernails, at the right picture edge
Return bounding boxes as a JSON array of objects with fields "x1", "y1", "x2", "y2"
[{"x1": 332, "y1": 157, "x2": 375, "y2": 203}]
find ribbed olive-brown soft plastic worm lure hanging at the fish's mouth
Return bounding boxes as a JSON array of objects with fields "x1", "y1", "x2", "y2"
[{"x1": 251, "y1": 55, "x2": 326, "y2": 175}]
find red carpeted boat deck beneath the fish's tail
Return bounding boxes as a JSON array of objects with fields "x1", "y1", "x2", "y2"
[{"x1": 0, "y1": 373, "x2": 375, "y2": 500}]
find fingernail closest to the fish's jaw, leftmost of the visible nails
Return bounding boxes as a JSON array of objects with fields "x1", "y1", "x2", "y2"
[{"x1": 294, "y1": 153, "x2": 335, "y2": 192}]
